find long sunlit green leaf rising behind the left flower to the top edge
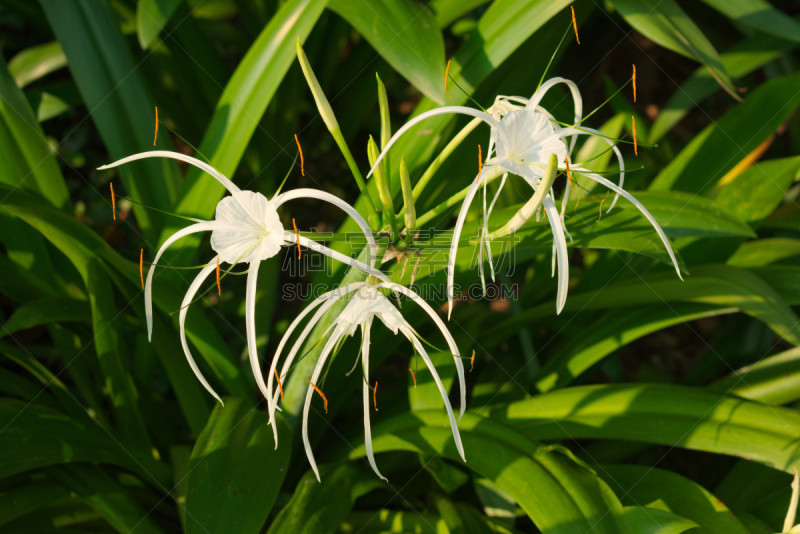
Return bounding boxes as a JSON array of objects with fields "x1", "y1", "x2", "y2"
[{"x1": 170, "y1": 0, "x2": 325, "y2": 228}]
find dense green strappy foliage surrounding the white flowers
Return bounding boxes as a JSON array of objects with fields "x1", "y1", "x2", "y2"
[{"x1": 0, "y1": 0, "x2": 800, "y2": 533}]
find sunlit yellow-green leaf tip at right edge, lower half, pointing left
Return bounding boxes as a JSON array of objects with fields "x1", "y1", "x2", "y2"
[{"x1": 709, "y1": 348, "x2": 800, "y2": 404}]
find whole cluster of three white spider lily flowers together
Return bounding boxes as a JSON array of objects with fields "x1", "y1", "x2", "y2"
[{"x1": 101, "y1": 70, "x2": 680, "y2": 478}]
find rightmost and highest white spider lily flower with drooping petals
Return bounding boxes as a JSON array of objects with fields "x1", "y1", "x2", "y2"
[{"x1": 367, "y1": 77, "x2": 683, "y2": 317}]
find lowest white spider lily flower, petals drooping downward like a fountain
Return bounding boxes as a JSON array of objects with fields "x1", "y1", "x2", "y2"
[{"x1": 266, "y1": 281, "x2": 466, "y2": 480}]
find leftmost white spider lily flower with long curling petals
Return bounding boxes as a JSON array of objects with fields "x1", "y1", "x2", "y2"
[{"x1": 99, "y1": 150, "x2": 385, "y2": 402}]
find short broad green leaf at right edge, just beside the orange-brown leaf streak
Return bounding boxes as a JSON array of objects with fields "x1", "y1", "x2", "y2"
[{"x1": 716, "y1": 156, "x2": 800, "y2": 223}]
